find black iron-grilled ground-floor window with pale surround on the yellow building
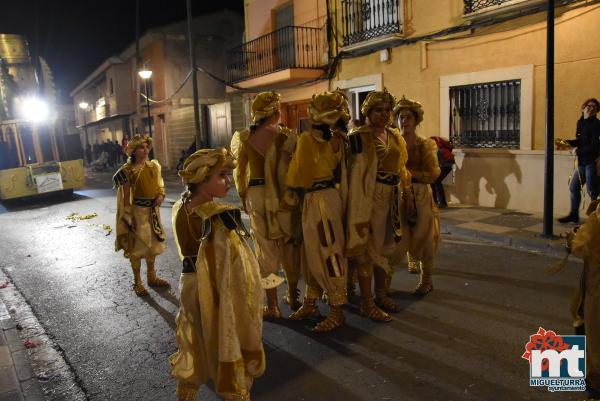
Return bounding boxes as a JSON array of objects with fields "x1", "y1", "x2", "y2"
[{"x1": 450, "y1": 79, "x2": 521, "y2": 149}]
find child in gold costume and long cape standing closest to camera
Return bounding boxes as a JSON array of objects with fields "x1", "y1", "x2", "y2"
[{"x1": 170, "y1": 148, "x2": 265, "y2": 401}]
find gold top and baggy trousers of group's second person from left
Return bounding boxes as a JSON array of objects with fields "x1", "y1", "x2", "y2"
[{"x1": 287, "y1": 130, "x2": 348, "y2": 305}]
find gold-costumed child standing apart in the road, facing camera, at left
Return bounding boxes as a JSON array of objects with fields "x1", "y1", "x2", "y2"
[{"x1": 113, "y1": 135, "x2": 169, "y2": 296}]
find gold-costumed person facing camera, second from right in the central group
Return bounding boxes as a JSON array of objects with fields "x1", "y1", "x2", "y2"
[{"x1": 346, "y1": 90, "x2": 412, "y2": 322}]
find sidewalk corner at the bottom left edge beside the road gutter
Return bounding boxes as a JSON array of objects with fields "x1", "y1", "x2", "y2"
[{"x1": 0, "y1": 296, "x2": 46, "y2": 401}]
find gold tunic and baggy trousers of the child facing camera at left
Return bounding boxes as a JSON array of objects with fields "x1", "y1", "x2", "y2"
[{"x1": 115, "y1": 160, "x2": 165, "y2": 259}]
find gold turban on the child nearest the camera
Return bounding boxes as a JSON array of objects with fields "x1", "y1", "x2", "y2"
[{"x1": 178, "y1": 148, "x2": 237, "y2": 184}]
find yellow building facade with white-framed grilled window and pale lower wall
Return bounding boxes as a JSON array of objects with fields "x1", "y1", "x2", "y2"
[{"x1": 329, "y1": 0, "x2": 600, "y2": 214}]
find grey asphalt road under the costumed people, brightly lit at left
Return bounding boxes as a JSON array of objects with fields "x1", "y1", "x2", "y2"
[{"x1": 0, "y1": 178, "x2": 582, "y2": 401}]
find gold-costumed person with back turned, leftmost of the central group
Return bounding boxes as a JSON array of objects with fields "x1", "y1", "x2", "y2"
[{"x1": 231, "y1": 92, "x2": 300, "y2": 318}]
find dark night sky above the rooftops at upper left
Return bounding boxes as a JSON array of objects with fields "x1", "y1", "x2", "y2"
[{"x1": 0, "y1": 0, "x2": 244, "y2": 102}]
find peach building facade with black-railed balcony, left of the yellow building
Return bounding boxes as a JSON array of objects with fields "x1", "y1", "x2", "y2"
[{"x1": 227, "y1": 0, "x2": 330, "y2": 131}]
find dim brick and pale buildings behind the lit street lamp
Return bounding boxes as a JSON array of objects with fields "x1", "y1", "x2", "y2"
[{"x1": 71, "y1": 10, "x2": 246, "y2": 169}]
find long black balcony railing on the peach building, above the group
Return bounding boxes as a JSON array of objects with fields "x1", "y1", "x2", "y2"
[{"x1": 227, "y1": 26, "x2": 327, "y2": 83}]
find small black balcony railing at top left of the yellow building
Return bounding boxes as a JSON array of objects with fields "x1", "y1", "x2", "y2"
[{"x1": 342, "y1": 0, "x2": 402, "y2": 46}]
